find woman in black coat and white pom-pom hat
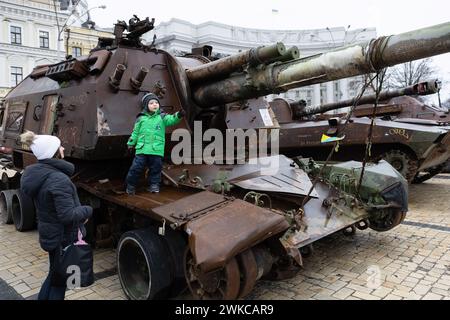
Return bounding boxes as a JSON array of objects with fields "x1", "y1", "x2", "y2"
[{"x1": 20, "y1": 131, "x2": 92, "y2": 300}]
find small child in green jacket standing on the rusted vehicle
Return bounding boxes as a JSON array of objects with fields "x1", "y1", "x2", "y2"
[{"x1": 126, "y1": 93, "x2": 184, "y2": 194}]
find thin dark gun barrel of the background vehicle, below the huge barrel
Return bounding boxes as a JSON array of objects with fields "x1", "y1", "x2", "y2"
[{"x1": 291, "y1": 80, "x2": 440, "y2": 118}]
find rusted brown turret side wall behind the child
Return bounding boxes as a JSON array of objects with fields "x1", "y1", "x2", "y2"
[{"x1": 4, "y1": 47, "x2": 186, "y2": 160}]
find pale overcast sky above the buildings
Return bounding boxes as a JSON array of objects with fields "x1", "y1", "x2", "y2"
[{"x1": 87, "y1": 0, "x2": 450, "y2": 102}]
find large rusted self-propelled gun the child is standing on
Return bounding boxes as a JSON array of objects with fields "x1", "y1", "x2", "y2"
[{"x1": 0, "y1": 18, "x2": 450, "y2": 299}]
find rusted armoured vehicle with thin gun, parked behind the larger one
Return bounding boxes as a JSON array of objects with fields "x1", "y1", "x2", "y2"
[{"x1": 271, "y1": 81, "x2": 450, "y2": 183}]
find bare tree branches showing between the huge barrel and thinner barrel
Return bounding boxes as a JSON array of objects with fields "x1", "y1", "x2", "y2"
[{"x1": 385, "y1": 58, "x2": 437, "y2": 89}]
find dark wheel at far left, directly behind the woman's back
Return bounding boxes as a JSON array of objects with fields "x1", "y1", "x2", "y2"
[{"x1": 11, "y1": 190, "x2": 36, "y2": 232}]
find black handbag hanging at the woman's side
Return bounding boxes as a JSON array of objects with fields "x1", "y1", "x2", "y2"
[{"x1": 52, "y1": 230, "x2": 94, "y2": 288}]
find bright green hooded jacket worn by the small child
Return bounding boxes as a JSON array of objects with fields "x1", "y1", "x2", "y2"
[{"x1": 127, "y1": 109, "x2": 181, "y2": 157}]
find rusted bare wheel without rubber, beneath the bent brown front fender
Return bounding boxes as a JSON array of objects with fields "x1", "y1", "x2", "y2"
[{"x1": 184, "y1": 250, "x2": 240, "y2": 300}]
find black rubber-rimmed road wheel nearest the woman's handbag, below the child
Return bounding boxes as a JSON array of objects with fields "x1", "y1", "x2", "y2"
[{"x1": 117, "y1": 228, "x2": 171, "y2": 300}]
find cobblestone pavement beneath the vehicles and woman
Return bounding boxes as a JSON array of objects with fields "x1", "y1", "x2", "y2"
[{"x1": 0, "y1": 175, "x2": 450, "y2": 300}]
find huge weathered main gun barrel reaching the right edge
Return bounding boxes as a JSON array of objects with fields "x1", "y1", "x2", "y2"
[{"x1": 193, "y1": 22, "x2": 450, "y2": 107}]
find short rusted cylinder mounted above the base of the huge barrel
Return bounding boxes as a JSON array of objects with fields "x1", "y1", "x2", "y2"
[{"x1": 186, "y1": 42, "x2": 286, "y2": 83}]
